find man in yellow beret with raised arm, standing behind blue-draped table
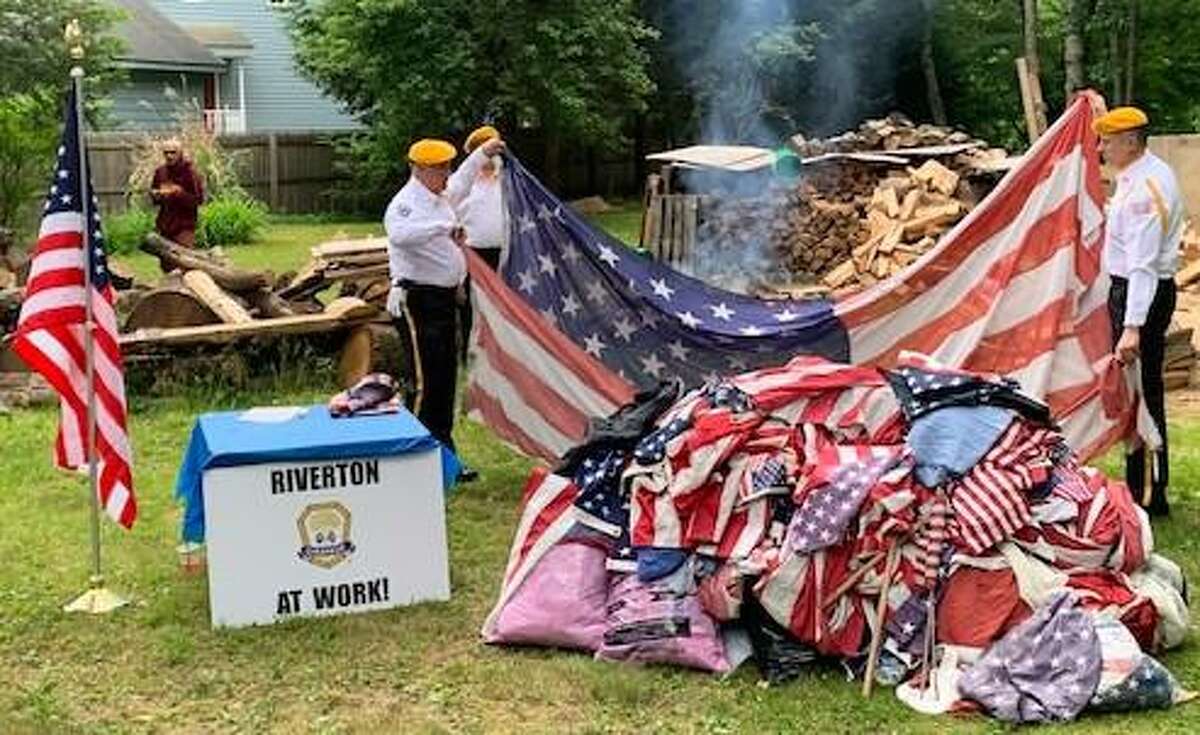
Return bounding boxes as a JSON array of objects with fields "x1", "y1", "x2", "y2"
[{"x1": 383, "y1": 139, "x2": 504, "y2": 480}]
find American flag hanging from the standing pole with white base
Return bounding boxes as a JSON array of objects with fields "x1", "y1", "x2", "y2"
[{"x1": 12, "y1": 90, "x2": 138, "y2": 528}]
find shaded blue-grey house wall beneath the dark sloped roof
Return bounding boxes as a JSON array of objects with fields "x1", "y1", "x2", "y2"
[{"x1": 104, "y1": 70, "x2": 206, "y2": 130}]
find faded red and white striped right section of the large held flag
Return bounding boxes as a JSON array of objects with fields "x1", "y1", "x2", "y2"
[{"x1": 836, "y1": 98, "x2": 1130, "y2": 460}]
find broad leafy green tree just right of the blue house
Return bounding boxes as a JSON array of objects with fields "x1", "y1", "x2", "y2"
[{"x1": 293, "y1": 0, "x2": 653, "y2": 189}]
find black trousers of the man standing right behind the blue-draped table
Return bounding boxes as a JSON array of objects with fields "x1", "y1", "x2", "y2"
[{"x1": 395, "y1": 283, "x2": 458, "y2": 449}]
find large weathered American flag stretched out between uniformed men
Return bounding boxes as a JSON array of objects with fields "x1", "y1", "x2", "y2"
[{"x1": 467, "y1": 97, "x2": 1133, "y2": 459}]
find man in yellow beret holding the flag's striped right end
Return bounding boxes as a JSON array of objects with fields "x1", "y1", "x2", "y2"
[{"x1": 1092, "y1": 107, "x2": 1184, "y2": 515}]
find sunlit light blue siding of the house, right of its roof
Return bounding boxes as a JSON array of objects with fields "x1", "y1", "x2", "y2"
[{"x1": 141, "y1": 0, "x2": 359, "y2": 132}]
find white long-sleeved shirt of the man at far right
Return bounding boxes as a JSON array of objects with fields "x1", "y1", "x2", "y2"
[{"x1": 1104, "y1": 151, "x2": 1186, "y2": 327}]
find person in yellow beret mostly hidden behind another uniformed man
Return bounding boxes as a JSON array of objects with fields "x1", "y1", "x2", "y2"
[{"x1": 452, "y1": 125, "x2": 509, "y2": 360}]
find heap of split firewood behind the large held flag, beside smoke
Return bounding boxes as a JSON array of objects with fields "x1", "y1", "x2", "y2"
[{"x1": 691, "y1": 115, "x2": 1008, "y2": 294}]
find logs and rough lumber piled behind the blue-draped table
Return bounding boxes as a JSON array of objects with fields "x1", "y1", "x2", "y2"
[{"x1": 0, "y1": 233, "x2": 403, "y2": 391}]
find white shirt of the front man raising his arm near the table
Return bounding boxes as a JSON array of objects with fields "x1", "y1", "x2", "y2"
[{"x1": 383, "y1": 149, "x2": 486, "y2": 288}]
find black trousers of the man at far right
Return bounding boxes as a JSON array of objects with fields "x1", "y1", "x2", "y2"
[{"x1": 1109, "y1": 276, "x2": 1175, "y2": 513}]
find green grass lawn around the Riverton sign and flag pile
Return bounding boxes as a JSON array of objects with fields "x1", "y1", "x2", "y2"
[{"x1": 0, "y1": 210, "x2": 1200, "y2": 735}]
